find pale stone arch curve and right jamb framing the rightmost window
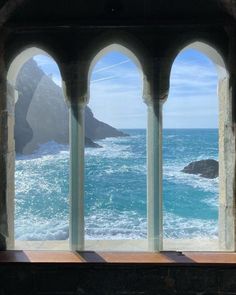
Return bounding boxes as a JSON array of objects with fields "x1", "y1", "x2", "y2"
[{"x1": 166, "y1": 41, "x2": 235, "y2": 250}]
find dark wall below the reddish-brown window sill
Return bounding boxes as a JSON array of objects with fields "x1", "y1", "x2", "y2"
[{"x1": 0, "y1": 263, "x2": 236, "y2": 295}]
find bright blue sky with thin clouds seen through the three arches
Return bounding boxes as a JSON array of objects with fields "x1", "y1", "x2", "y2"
[{"x1": 34, "y1": 49, "x2": 218, "y2": 129}]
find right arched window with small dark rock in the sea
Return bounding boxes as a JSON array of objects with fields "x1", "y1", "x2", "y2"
[{"x1": 163, "y1": 42, "x2": 227, "y2": 251}]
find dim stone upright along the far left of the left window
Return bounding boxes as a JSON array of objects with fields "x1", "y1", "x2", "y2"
[{"x1": 0, "y1": 30, "x2": 15, "y2": 250}]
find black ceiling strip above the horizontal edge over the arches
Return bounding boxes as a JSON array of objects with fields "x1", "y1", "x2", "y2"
[{"x1": 0, "y1": 0, "x2": 236, "y2": 25}]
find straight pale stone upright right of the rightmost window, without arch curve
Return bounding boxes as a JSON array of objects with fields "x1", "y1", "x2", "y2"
[{"x1": 218, "y1": 78, "x2": 236, "y2": 251}]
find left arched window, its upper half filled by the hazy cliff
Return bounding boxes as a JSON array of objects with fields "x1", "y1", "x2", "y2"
[{"x1": 8, "y1": 47, "x2": 69, "y2": 249}]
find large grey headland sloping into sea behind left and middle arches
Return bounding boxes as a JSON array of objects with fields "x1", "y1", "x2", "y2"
[{"x1": 14, "y1": 59, "x2": 126, "y2": 154}]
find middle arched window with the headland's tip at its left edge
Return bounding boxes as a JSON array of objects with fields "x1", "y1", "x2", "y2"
[{"x1": 85, "y1": 45, "x2": 147, "y2": 250}]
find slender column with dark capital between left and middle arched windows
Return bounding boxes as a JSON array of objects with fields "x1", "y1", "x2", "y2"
[{"x1": 61, "y1": 63, "x2": 88, "y2": 251}]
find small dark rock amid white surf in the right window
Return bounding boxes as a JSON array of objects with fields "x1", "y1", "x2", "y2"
[{"x1": 181, "y1": 159, "x2": 219, "y2": 178}]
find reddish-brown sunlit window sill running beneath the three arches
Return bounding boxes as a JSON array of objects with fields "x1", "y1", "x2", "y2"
[{"x1": 0, "y1": 250, "x2": 236, "y2": 266}]
